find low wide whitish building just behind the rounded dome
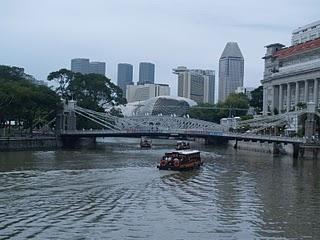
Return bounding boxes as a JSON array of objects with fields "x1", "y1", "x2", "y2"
[{"x1": 126, "y1": 84, "x2": 170, "y2": 102}]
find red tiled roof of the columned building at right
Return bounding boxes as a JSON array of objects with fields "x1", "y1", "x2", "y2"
[{"x1": 273, "y1": 38, "x2": 320, "y2": 58}]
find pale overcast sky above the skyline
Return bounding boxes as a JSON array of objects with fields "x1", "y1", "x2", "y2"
[{"x1": 0, "y1": 0, "x2": 320, "y2": 95}]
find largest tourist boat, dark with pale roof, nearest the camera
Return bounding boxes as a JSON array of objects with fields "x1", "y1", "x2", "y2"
[{"x1": 157, "y1": 150, "x2": 203, "y2": 171}]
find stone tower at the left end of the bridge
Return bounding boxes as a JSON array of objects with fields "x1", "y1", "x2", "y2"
[{"x1": 56, "y1": 100, "x2": 77, "y2": 135}]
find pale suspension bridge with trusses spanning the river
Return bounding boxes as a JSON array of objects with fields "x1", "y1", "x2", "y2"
[{"x1": 50, "y1": 101, "x2": 312, "y2": 158}]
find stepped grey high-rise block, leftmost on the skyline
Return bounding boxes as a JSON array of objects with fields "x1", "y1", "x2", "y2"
[{"x1": 71, "y1": 58, "x2": 106, "y2": 76}]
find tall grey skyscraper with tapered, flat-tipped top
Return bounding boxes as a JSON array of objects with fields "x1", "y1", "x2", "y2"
[{"x1": 219, "y1": 42, "x2": 244, "y2": 102}]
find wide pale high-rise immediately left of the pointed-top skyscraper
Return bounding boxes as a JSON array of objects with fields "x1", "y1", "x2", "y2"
[{"x1": 173, "y1": 66, "x2": 215, "y2": 104}]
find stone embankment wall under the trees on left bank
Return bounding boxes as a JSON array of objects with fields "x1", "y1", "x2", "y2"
[{"x1": 0, "y1": 137, "x2": 62, "y2": 151}]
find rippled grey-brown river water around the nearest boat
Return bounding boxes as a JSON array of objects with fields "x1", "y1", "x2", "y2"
[{"x1": 0, "y1": 139, "x2": 320, "y2": 240}]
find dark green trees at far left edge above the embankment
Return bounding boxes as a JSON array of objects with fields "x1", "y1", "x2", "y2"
[{"x1": 0, "y1": 66, "x2": 60, "y2": 135}]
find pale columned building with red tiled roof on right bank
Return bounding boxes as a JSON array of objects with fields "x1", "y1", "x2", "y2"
[{"x1": 261, "y1": 24, "x2": 320, "y2": 114}]
